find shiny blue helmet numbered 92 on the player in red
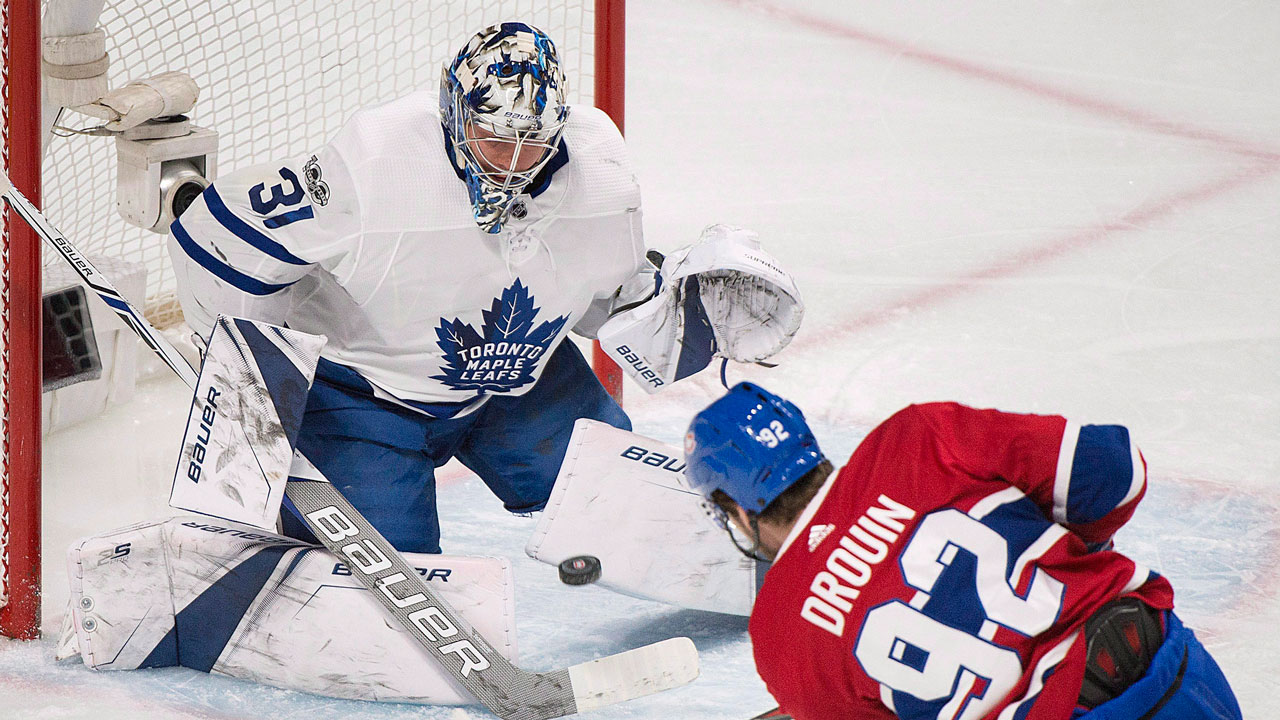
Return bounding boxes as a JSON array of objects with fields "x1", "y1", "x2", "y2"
[{"x1": 685, "y1": 383, "x2": 823, "y2": 512}]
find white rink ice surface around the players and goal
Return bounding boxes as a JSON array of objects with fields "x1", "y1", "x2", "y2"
[{"x1": 0, "y1": 0, "x2": 1280, "y2": 720}]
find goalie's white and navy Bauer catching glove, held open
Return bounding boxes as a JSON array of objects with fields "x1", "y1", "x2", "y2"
[{"x1": 599, "y1": 225, "x2": 804, "y2": 393}]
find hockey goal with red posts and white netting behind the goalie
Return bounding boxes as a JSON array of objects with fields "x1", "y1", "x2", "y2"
[{"x1": 0, "y1": 0, "x2": 625, "y2": 638}]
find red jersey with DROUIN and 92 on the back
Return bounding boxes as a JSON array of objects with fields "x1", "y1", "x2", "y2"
[{"x1": 750, "y1": 404, "x2": 1172, "y2": 720}]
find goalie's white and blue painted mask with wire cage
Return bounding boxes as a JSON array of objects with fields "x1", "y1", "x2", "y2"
[{"x1": 440, "y1": 23, "x2": 568, "y2": 233}]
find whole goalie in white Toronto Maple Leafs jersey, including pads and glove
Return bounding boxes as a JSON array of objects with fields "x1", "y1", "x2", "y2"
[{"x1": 63, "y1": 23, "x2": 803, "y2": 708}]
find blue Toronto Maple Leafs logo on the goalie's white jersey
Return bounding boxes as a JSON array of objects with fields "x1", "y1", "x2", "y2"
[{"x1": 431, "y1": 279, "x2": 568, "y2": 393}]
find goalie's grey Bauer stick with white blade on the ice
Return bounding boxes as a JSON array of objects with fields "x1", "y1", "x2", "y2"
[{"x1": 0, "y1": 170, "x2": 698, "y2": 720}]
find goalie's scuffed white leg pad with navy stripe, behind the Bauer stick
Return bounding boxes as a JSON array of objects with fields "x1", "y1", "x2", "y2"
[{"x1": 68, "y1": 516, "x2": 516, "y2": 705}]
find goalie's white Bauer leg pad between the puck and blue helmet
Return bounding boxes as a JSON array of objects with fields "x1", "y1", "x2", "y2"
[{"x1": 525, "y1": 420, "x2": 758, "y2": 615}]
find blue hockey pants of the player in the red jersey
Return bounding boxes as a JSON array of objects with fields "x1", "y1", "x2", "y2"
[{"x1": 1073, "y1": 611, "x2": 1240, "y2": 720}]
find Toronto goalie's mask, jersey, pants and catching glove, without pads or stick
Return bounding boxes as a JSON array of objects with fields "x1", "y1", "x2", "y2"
[{"x1": 161, "y1": 23, "x2": 803, "y2": 553}]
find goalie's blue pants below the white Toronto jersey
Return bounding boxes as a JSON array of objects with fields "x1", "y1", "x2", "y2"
[{"x1": 282, "y1": 341, "x2": 631, "y2": 552}]
